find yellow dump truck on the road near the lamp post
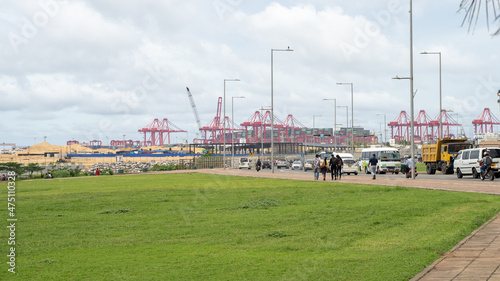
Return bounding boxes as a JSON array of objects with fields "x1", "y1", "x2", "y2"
[{"x1": 422, "y1": 138, "x2": 472, "y2": 175}]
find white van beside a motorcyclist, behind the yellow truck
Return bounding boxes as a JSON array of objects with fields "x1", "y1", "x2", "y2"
[{"x1": 453, "y1": 147, "x2": 500, "y2": 178}]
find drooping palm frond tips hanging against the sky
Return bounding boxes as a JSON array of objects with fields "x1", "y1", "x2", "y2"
[{"x1": 460, "y1": 0, "x2": 500, "y2": 36}]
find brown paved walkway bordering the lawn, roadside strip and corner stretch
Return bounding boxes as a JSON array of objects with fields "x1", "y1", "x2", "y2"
[{"x1": 197, "y1": 169, "x2": 500, "y2": 281}]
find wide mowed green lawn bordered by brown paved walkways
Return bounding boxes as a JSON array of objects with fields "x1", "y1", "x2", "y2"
[{"x1": 0, "y1": 174, "x2": 500, "y2": 281}]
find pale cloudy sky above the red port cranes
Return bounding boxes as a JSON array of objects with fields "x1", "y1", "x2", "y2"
[{"x1": 0, "y1": 0, "x2": 500, "y2": 146}]
